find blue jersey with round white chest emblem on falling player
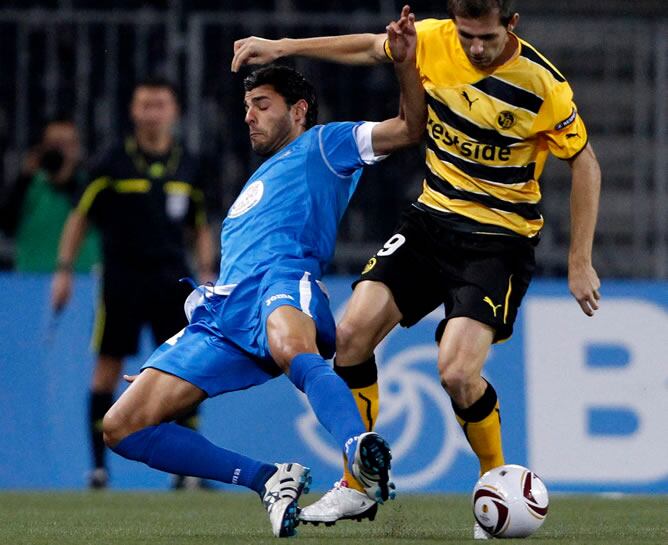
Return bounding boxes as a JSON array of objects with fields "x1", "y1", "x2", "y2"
[{"x1": 217, "y1": 122, "x2": 377, "y2": 285}]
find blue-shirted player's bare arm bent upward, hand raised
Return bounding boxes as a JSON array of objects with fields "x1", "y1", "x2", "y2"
[{"x1": 372, "y1": 6, "x2": 427, "y2": 155}]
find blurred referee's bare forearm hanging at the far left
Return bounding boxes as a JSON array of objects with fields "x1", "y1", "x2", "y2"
[{"x1": 51, "y1": 209, "x2": 88, "y2": 312}]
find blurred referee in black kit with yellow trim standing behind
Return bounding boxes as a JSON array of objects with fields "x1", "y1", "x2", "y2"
[{"x1": 51, "y1": 78, "x2": 215, "y2": 488}]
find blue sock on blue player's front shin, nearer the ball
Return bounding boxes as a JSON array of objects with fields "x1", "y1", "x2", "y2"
[{"x1": 288, "y1": 354, "x2": 366, "y2": 450}]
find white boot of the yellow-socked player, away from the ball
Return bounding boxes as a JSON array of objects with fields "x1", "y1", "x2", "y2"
[{"x1": 299, "y1": 479, "x2": 378, "y2": 526}]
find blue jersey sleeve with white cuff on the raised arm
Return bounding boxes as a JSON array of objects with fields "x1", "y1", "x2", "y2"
[{"x1": 318, "y1": 121, "x2": 386, "y2": 177}]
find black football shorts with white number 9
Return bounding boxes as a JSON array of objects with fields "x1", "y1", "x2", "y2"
[{"x1": 353, "y1": 205, "x2": 535, "y2": 342}]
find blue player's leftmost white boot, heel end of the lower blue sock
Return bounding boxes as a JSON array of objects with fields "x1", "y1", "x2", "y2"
[{"x1": 262, "y1": 463, "x2": 311, "y2": 537}]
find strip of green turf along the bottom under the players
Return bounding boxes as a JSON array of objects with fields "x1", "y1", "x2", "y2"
[{"x1": 0, "y1": 492, "x2": 668, "y2": 545}]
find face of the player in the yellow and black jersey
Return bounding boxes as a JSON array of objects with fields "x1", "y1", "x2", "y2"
[{"x1": 455, "y1": 10, "x2": 517, "y2": 69}]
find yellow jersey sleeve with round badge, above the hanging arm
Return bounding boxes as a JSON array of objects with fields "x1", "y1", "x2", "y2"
[{"x1": 535, "y1": 82, "x2": 588, "y2": 159}]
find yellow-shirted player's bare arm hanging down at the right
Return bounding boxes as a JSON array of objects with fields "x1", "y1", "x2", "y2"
[{"x1": 568, "y1": 144, "x2": 601, "y2": 316}]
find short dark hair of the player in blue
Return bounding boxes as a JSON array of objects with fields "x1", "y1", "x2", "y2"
[{"x1": 244, "y1": 65, "x2": 318, "y2": 129}]
